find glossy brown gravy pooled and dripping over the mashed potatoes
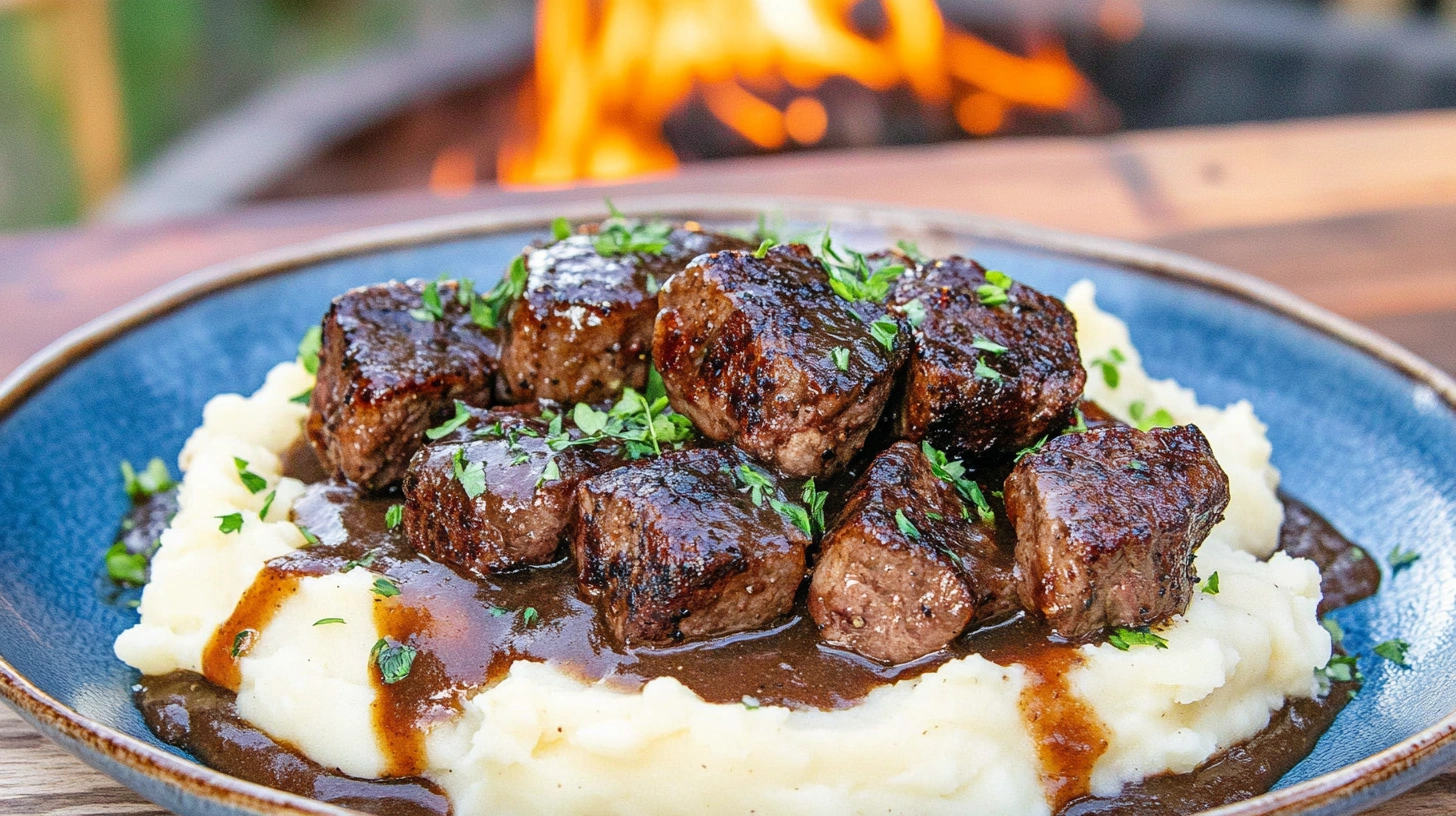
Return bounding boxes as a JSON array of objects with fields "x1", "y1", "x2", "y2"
[{"x1": 133, "y1": 442, "x2": 1379, "y2": 813}]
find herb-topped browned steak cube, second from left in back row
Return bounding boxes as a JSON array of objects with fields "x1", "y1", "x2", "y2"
[{"x1": 498, "y1": 224, "x2": 745, "y2": 404}]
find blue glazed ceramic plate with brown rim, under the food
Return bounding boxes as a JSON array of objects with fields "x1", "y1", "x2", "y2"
[{"x1": 0, "y1": 197, "x2": 1456, "y2": 815}]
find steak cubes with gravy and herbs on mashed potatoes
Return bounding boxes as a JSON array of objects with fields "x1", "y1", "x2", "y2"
[{"x1": 114, "y1": 213, "x2": 1379, "y2": 816}]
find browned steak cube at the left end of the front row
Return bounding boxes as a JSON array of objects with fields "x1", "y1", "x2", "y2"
[{"x1": 405, "y1": 407, "x2": 626, "y2": 574}]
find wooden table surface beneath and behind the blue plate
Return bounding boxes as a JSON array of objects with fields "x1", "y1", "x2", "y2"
[{"x1": 0, "y1": 112, "x2": 1456, "y2": 816}]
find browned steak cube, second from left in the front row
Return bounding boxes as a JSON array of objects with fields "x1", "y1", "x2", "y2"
[{"x1": 572, "y1": 449, "x2": 811, "y2": 646}]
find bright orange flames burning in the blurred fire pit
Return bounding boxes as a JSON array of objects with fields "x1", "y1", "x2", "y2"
[{"x1": 496, "y1": 0, "x2": 1089, "y2": 185}]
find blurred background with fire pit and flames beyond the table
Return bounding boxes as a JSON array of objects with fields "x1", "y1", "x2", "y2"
[{"x1": 0, "y1": 0, "x2": 1456, "y2": 230}]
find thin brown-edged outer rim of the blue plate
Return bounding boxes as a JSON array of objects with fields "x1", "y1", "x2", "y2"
[{"x1": 0, "y1": 195, "x2": 1456, "y2": 816}]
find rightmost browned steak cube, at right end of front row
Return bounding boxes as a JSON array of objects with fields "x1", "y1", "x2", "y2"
[{"x1": 1006, "y1": 425, "x2": 1229, "y2": 638}]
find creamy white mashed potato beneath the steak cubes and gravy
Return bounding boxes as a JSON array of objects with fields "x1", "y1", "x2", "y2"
[{"x1": 116, "y1": 283, "x2": 1329, "y2": 816}]
